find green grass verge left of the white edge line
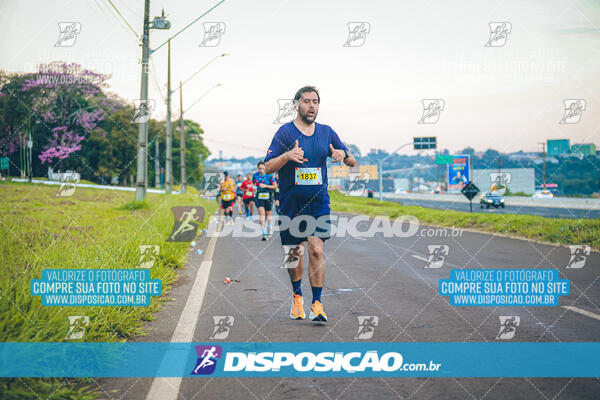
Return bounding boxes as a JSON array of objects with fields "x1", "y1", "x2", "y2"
[{"x1": 0, "y1": 183, "x2": 217, "y2": 399}]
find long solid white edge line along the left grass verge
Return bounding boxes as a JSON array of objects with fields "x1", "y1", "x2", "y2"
[{"x1": 146, "y1": 225, "x2": 222, "y2": 400}]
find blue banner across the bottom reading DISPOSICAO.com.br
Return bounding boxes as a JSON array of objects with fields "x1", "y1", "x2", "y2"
[{"x1": 0, "y1": 342, "x2": 600, "y2": 378}]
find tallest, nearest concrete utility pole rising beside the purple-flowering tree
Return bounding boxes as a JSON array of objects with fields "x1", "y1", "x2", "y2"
[{"x1": 135, "y1": 0, "x2": 150, "y2": 201}]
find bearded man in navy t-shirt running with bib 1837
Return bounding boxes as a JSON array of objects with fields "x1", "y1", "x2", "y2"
[{"x1": 264, "y1": 86, "x2": 356, "y2": 322}]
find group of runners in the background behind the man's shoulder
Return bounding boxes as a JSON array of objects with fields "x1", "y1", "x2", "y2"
[{"x1": 219, "y1": 161, "x2": 279, "y2": 240}]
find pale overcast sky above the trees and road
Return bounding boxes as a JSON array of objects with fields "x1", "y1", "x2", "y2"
[{"x1": 0, "y1": 0, "x2": 600, "y2": 157}]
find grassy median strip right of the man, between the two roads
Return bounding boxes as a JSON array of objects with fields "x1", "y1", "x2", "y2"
[{"x1": 329, "y1": 191, "x2": 600, "y2": 250}]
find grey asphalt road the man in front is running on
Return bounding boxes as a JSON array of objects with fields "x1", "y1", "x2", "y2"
[{"x1": 96, "y1": 211, "x2": 600, "y2": 400}]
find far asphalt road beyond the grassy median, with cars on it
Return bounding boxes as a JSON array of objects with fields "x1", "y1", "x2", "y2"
[{"x1": 384, "y1": 196, "x2": 600, "y2": 218}]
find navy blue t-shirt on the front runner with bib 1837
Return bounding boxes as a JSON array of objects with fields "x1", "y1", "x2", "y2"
[{"x1": 264, "y1": 121, "x2": 348, "y2": 205}]
